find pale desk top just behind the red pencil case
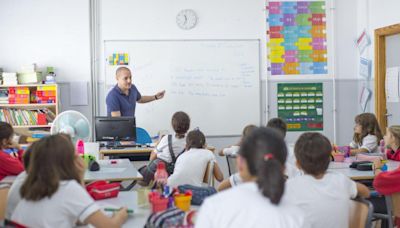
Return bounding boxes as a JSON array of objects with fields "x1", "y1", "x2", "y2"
[{"x1": 84, "y1": 159, "x2": 143, "y2": 182}]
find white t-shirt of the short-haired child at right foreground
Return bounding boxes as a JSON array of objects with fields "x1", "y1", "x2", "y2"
[{"x1": 285, "y1": 171, "x2": 357, "y2": 228}]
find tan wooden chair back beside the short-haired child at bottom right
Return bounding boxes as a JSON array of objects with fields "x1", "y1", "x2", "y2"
[{"x1": 349, "y1": 198, "x2": 374, "y2": 228}]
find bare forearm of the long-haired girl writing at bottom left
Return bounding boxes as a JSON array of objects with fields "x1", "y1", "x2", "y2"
[{"x1": 84, "y1": 207, "x2": 128, "y2": 228}]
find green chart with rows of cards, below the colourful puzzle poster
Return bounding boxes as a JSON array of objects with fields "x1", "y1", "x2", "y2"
[{"x1": 277, "y1": 83, "x2": 324, "y2": 131}]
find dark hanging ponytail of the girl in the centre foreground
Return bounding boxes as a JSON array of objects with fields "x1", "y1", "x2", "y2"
[{"x1": 257, "y1": 158, "x2": 285, "y2": 205}]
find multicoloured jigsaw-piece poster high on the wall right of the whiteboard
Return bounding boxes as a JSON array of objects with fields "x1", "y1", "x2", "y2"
[{"x1": 267, "y1": 1, "x2": 328, "y2": 75}]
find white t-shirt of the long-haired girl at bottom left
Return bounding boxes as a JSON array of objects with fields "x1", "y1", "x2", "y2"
[{"x1": 11, "y1": 180, "x2": 100, "y2": 228}]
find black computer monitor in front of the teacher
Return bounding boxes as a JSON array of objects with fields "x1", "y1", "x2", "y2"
[{"x1": 95, "y1": 116, "x2": 136, "y2": 141}]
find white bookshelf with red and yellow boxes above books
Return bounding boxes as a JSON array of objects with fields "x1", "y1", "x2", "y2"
[{"x1": 0, "y1": 84, "x2": 59, "y2": 136}]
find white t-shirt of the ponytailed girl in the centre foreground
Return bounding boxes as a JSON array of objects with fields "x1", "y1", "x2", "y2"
[{"x1": 196, "y1": 182, "x2": 304, "y2": 228}]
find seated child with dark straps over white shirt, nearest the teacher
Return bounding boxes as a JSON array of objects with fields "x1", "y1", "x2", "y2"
[{"x1": 139, "y1": 112, "x2": 190, "y2": 185}]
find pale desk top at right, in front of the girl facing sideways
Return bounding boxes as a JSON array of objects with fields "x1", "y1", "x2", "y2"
[{"x1": 328, "y1": 160, "x2": 400, "y2": 180}]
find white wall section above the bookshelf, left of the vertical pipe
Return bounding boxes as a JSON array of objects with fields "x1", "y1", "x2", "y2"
[{"x1": 0, "y1": 0, "x2": 92, "y2": 119}]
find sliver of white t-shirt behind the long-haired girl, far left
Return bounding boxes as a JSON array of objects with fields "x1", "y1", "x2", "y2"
[{"x1": 6, "y1": 171, "x2": 27, "y2": 219}]
